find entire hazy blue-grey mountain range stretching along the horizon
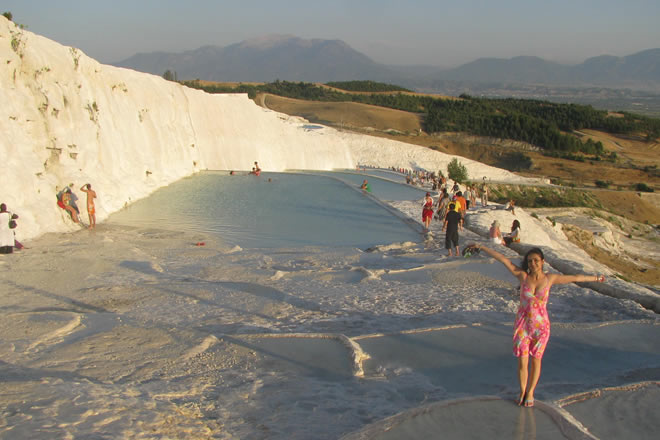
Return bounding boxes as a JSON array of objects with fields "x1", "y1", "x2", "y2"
[{"x1": 115, "y1": 35, "x2": 660, "y2": 90}]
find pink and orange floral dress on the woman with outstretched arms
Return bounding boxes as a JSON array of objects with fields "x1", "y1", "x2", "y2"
[{"x1": 513, "y1": 278, "x2": 550, "y2": 359}]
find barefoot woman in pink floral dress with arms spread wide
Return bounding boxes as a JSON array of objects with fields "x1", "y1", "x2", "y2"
[{"x1": 468, "y1": 244, "x2": 605, "y2": 407}]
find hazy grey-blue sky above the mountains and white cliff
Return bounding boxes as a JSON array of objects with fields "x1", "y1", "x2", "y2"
[{"x1": 5, "y1": 0, "x2": 660, "y2": 67}]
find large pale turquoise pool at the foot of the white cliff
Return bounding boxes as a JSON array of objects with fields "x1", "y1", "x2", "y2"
[{"x1": 108, "y1": 172, "x2": 420, "y2": 248}]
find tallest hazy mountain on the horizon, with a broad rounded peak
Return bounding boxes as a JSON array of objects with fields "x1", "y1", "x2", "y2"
[{"x1": 115, "y1": 35, "x2": 396, "y2": 82}]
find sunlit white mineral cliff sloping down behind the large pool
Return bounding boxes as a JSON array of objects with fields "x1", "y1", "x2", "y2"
[{"x1": 0, "y1": 17, "x2": 536, "y2": 240}]
